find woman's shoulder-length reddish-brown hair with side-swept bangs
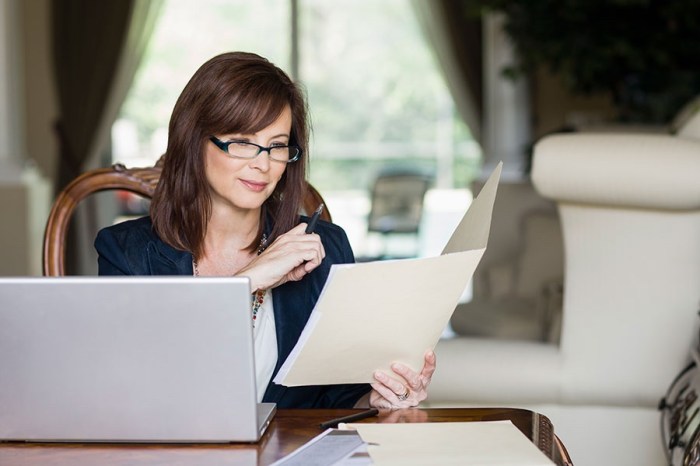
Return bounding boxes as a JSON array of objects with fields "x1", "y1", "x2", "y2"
[{"x1": 150, "y1": 52, "x2": 309, "y2": 257}]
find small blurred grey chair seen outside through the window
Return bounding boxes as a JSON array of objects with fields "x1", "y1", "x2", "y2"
[{"x1": 367, "y1": 169, "x2": 432, "y2": 258}]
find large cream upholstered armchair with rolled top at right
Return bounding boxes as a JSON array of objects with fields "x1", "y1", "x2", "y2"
[{"x1": 429, "y1": 128, "x2": 700, "y2": 466}]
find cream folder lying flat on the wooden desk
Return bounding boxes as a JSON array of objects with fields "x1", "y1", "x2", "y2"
[{"x1": 345, "y1": 421, "x2": 554, "y2": 466}]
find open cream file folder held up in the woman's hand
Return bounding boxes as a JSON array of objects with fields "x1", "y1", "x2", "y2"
[{"x1": 274, "y1": 163, "x2": 502, "y2": 386}]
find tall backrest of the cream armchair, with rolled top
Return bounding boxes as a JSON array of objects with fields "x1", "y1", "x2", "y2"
[{"x1": 532, "y1": 133, "x2": 700, "y2": 404}]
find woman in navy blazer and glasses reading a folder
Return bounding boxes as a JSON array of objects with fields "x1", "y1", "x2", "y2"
[{"x1": 95, "y1": 52, "x2": 435, "y2": 408}]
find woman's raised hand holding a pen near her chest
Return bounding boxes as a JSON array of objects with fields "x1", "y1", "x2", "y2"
[{"x1": 236, "y1": 223, "x2": 326, "y2": 292}]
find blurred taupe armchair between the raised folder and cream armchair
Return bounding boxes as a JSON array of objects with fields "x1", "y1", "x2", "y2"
[{"x1": 450, "y1": 207, "x2": 564, "y2": 343}]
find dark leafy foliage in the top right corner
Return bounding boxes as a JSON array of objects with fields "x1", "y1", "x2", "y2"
[{"x1": 465, "y1": 0, "x2": 700, "y2": 123}]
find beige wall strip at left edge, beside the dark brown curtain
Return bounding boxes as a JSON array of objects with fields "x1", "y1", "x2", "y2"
[{"x1": 0, "y1": 0, "x2": 56, "y2": 275}]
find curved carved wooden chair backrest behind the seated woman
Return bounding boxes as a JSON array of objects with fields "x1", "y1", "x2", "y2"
[{"x1": 43, "y1": 158, "x2": 332, "y2": 277}]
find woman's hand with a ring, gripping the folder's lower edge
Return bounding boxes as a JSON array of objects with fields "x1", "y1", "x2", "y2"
[{"x1": 369, "y1": 351, "x2": 436, "y2": 409}]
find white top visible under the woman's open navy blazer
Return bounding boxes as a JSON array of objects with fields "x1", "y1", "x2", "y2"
[{"x1": 253, "y1": 290, "x2": 277, "y2": 402}]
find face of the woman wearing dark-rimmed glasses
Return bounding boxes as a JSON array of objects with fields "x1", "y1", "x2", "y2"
[{"x1": 204, "y1": 106, "x2": 292, "y2": 215}]
